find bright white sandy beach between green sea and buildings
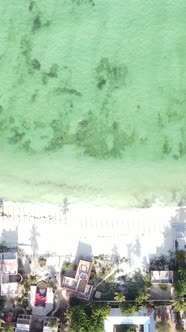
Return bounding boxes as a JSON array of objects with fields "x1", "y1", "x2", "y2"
[{"x1": 0, "y1": 201, "x2": 186, "y2": 270}]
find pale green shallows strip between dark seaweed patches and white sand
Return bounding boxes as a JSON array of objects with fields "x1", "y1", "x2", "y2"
[{"x1": 0, "y1": 145, "x2": 186, "y2": 208}]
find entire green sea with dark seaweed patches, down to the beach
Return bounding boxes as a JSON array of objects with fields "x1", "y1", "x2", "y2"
[{"x1": 0, "y1": 0, "x2": 186, "y2": 207}]
